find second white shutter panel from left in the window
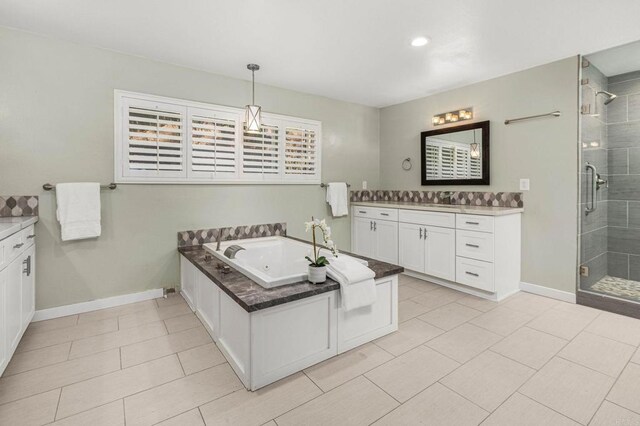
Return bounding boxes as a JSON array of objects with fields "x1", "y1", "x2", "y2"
[{"x1": 189, "y1": 108, "x2": 238, "y2": 178}]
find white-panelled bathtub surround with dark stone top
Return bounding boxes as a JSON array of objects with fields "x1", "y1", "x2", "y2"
[{"x1": 178, "y1": 240, "x2": 403, "y2": 390}]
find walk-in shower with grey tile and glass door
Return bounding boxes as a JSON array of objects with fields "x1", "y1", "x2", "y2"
[{"x1": 578, "y1": 42, "x2": 640, "y2": 315}]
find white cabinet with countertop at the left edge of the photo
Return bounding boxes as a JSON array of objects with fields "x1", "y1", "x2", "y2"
[{"x1": 0, "y1": 216, "x2": 38, "y2": 375}]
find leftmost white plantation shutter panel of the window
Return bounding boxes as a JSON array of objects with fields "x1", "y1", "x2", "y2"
[{"x1": 122, "y1": 99, "x2": 186, "y2": 178}]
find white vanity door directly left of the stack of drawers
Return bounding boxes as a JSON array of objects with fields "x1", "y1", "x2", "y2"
[{"x1": 424, "y1": 226, "x2": 456, "y2": 281}]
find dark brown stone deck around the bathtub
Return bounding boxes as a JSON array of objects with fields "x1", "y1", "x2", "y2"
[{"x1": 178, "y1": 241, "x2": 404, "y2": 312}]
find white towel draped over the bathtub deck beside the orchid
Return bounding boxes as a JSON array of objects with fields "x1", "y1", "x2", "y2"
[{"x1": 327, "y1": 256, "x2": 377, "y2": 311}]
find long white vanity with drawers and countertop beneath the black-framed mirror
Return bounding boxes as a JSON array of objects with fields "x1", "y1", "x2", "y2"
[{"x1": 351, "y1": 201, "x2": 524, "y2": 300}]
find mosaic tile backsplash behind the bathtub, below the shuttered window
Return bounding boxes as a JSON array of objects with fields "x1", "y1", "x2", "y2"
[{"x1": 178, "y1": 223, "x2": 287, "y2": 247}]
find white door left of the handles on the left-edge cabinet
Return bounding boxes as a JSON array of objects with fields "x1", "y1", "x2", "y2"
[{"x1": 5, "y1": 256, "x2": 22, "y2": 353}]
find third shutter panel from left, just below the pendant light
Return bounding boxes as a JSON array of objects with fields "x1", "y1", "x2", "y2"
[{"x1": 242, "y1": 123, "x2": 280, "y2": 178}]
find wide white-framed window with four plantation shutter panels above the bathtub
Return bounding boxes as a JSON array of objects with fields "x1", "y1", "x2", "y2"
[{"x1": 115, "y1": 91, "x2": 321, "y2": 184}]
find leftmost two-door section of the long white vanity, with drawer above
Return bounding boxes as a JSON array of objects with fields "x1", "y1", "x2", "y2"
[{"x1": 351, "y1": 208, "x2": 398, "y2": 264}]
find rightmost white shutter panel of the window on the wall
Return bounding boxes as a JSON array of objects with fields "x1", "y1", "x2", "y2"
[{"x1": 284, "y1": 127, "x2": 318, "y2": 177}]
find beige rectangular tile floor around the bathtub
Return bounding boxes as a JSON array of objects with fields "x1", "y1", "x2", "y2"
[{"x1": 0, "y1": 276, "x2": 640, "y2": 426}]
